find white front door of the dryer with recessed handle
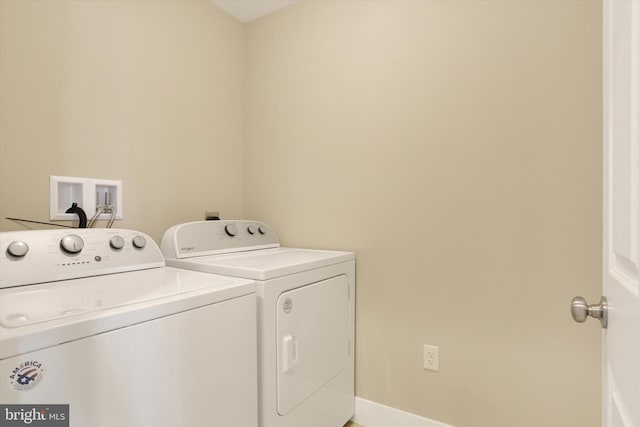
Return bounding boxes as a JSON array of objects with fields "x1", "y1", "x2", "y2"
[{"x1": 276, "y1": 275, "x2": 349, "y2": 415}]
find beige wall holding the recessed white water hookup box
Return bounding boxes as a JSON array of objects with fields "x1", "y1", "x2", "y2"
[{"x1": 0, "y1": 0, "x2": 244, "y2": 239}]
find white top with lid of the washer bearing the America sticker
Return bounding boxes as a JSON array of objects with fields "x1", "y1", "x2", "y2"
[{"x1": 0, "y1": 267, "x2": 255, "y2": 359}]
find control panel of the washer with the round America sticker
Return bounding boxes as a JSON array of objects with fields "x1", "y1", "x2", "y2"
[{"x1": 0, "y1": 228, "x2": 164, "y2": 288}]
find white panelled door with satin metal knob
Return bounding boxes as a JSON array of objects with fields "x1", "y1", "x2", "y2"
[{"x1": 602, "y1": 0, "x2": 640, "y2": 427}]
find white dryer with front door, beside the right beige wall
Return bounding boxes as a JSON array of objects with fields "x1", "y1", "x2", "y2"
[{"x1": 160, "y1": 221, "x2": 355, "y2": 427}]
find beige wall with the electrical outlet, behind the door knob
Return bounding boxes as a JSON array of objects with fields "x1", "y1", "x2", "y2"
[{"x1": 245, "y1": 0, "x2": 601, "y2": 427}]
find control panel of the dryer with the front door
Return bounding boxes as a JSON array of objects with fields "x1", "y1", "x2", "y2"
[{"x1": 160, "y1": 220, "x2": 280, "y2": 259}]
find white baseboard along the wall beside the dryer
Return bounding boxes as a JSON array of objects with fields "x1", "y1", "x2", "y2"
[{"x1": 352, "y1": 397, "x2": 453, "y2": 427}]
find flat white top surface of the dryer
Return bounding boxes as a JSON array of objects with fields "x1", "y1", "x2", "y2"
[{"x1": 165, "y1": 248, "x2": 355, "y2": 280}]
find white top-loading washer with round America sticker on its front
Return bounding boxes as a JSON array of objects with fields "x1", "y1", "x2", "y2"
[{"x1": 0, "y1": 229, "x2": 257, "y2": 427}]
